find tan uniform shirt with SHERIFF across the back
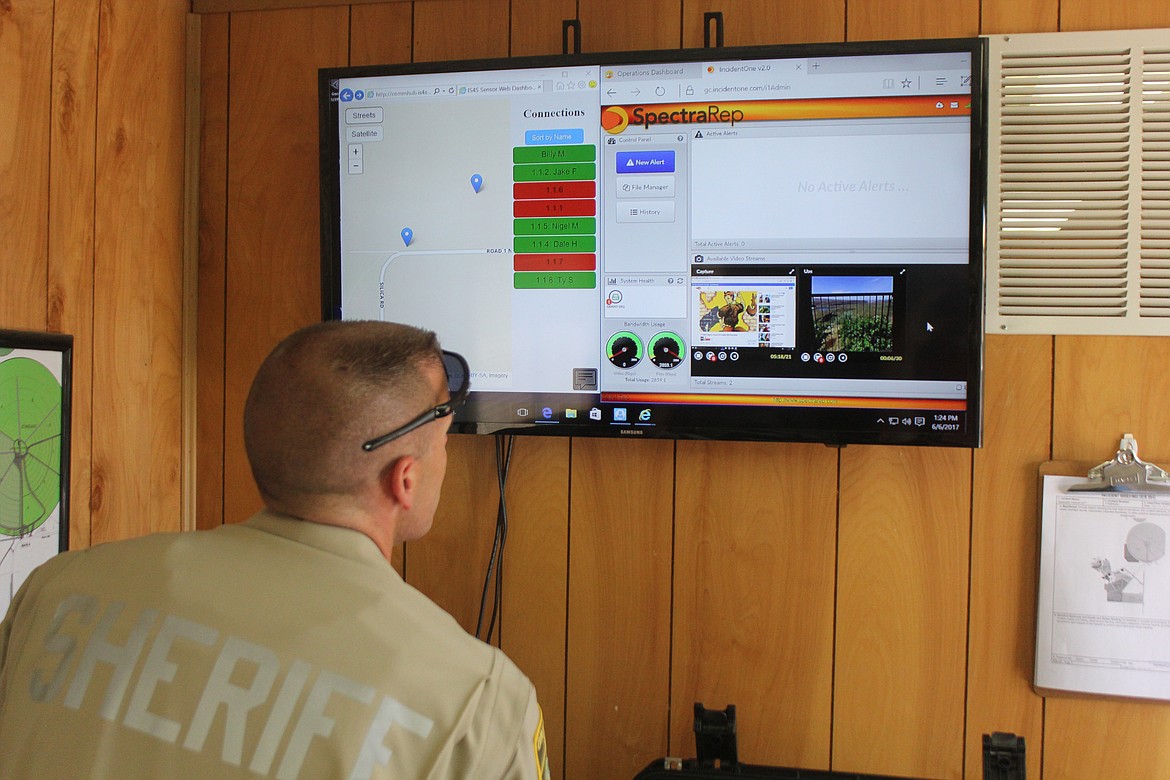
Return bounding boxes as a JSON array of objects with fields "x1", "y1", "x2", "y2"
[{"x1": 0, "y1": 512, "x2": 548, "y2": 780}]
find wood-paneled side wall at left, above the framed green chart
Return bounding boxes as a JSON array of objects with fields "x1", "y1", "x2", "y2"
[{"x1": 0, "y1": 0, "x2": 188, "y2": 547}]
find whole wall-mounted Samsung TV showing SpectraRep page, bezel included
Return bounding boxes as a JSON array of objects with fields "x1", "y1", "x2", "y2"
[{"x1": 319, "y1": 39, "x2": 986, "y2": 447}]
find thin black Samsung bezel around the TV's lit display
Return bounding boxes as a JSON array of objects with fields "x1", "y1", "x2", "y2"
[{"x1": 318, "y1": 36, "x2": 989, "y2": 448}]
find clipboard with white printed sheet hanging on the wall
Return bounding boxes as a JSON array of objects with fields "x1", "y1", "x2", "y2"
[{"x1": 1034, "y1": 434, "x2": 1170, "y2": 700}]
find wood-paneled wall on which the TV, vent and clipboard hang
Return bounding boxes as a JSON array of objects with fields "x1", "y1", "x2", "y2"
[{"x1": 197, "y1": 0, "x2": 1170, "y2": 780}]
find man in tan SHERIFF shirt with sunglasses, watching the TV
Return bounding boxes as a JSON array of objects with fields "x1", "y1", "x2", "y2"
[{"x1": 0, "y1": 322, "x2": 548, "y2": 780}]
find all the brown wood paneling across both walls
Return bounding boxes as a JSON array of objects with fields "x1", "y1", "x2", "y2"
[{"x1": 11, "y1": 0, "x2": 1170, "y2": 780}]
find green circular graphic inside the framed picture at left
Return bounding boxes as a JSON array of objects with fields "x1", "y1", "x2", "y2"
[{"x1": 0, "y1": 358, "x2": 61, "y2": 538}]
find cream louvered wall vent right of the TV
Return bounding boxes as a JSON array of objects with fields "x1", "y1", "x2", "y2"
[{"x1": 986, "y1": 29, "x2": 1170, "y2": 336}]
